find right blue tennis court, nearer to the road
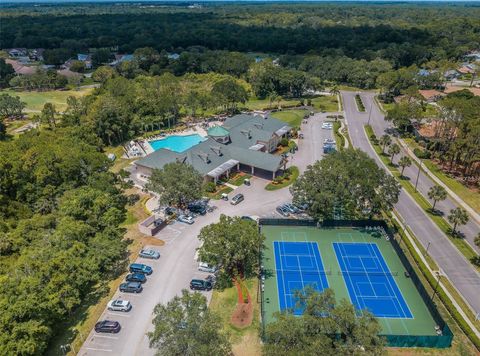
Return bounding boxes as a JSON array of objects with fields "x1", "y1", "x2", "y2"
[{"x1": 333, "y1": 242, "x2": 413, "y2": 319}]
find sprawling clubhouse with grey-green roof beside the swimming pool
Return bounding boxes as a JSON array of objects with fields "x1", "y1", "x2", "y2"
[{"x1": 135, "y1": 114, "x2": 292, "y2": 183}]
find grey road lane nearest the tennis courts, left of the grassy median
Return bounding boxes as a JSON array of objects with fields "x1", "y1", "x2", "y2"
[{"x1": 341, "y1": 91, "x2": 480, "y2": 313}]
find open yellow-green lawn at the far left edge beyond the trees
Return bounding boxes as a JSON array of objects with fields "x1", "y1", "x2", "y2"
[{"x1": 0, "y1": 88, "x2": 93, "y2": 112}]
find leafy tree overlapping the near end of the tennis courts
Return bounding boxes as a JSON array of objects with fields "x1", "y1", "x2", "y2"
[{"x1": 264, "y1": 287, "x2": 385, "y2": 356}]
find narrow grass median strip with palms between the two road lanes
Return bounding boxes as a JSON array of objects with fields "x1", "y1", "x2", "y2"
[{"x1": 365, "y1": 125, "x2": 480, "y2": 271}]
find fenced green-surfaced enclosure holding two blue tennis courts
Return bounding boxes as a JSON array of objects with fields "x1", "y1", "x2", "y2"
[{"x1": 260, "y1": 219, "x2": 453, "y2": 348}]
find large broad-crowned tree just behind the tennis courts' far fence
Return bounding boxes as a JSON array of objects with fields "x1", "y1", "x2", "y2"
[{"x1": 290, "y1": 149, "x2": 400, "y2": 220}]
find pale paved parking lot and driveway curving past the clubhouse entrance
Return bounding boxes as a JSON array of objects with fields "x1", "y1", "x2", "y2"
[{"x1": 79, "y1": 114, "x2": 333, "y2": 356}]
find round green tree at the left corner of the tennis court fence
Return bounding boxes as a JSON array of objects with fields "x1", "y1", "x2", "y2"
[{"x1": 198, "y1": 214, "x2": 265, "y2": 278}]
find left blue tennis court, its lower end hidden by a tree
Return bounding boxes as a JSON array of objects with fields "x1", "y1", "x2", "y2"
[{"x1": 274, "y1": 241, "x2": 328, "y2": 315}]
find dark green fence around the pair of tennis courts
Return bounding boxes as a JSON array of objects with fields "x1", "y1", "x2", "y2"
[{"x1": 259, "y1": 218, "x2": 453, "y2": 348}]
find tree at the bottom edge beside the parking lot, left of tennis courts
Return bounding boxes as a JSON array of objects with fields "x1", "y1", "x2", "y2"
[{"x1": 147, "y1": 289, "x2": 231, "y2": 356}]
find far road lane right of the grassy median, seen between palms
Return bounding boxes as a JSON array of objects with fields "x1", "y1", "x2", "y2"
[{"x1": 361, "y1": 93, "x2": 480, "y2": 252}]
